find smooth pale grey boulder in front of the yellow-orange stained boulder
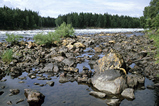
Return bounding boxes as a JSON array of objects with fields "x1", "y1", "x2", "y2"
[{"x1": 91, "y1": 70, "x2": 127, "y2": 94}]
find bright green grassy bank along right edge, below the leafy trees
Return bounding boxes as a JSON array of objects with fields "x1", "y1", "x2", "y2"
[{"x1": 146, "y1": 29, "x2": 159, "y2": 63}]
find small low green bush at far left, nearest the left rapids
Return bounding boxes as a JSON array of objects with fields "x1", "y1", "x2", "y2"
[{"x1": 5, "y1": 34, "x2": 23, "y2": 44}]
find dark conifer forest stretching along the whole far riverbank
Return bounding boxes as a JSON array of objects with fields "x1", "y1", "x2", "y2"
[{"x1": 0, "y1": 6, "x2": 141, "y2": 30}]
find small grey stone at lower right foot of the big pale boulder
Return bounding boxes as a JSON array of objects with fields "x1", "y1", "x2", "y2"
[{"x1": 121, "y1": 88, "x2": 135, "y2": 99}]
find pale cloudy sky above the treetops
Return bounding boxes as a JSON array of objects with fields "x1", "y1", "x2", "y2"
[{"x1": 0, "y1": 0, "x2": 151, "y2": 18}]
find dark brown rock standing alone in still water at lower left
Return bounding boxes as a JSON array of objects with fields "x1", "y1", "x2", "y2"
[{"x1": 24, "y1": 89, "x2": 45, "y2": 106}]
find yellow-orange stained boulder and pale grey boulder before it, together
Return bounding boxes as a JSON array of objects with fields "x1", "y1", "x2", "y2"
[{"x1": 91, "y1": 52, "x2": 127, "y2": 94}]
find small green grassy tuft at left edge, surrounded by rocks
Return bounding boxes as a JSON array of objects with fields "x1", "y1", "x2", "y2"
[{"x1": 1, "y1": 49, "x2": 13, "y2": 63}]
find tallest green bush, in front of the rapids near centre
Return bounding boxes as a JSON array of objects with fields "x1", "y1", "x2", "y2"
[{"x1": 55, "y1": 22, "x2": 74, "y2": 37}]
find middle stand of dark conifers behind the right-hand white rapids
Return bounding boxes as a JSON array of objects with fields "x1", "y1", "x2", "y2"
[{"x1": 55, "y1": 12, "x2": 140, "y2": 28}]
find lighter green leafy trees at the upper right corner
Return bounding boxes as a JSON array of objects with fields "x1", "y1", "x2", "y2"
[{"x1": 140, "y1": 0, "x2": 159, "y2": 29}]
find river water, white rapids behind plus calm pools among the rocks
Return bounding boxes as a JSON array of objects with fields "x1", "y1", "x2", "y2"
[{"x1": 0, "y1": 29, "x2": 158, "y2": 106}]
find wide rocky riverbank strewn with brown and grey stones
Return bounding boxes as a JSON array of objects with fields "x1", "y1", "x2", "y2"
[{"x1": 0, "y1": 33, "x2": 159, "y2": 105}]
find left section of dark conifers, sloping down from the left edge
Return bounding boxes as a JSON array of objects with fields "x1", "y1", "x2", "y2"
[{"x1": 0, "y1": 6, "x2": 56, "y2": 30}]
